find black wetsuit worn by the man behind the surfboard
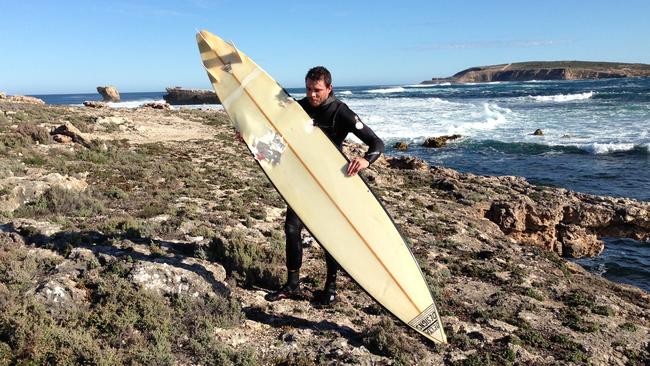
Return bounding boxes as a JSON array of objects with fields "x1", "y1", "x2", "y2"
[{"x1": 284, "y1": 96, "x2": 384, "y2": 286}]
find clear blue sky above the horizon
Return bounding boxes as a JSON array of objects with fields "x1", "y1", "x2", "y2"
[{"x1": 0, "y1": 0, "x2": 650, "y2": 94}]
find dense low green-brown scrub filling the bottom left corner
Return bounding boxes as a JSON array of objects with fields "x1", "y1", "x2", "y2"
[{"x1": 0, "y1": 236, "x2": 256, "y2": 365}]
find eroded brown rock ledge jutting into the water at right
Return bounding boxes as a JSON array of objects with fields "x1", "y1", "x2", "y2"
[{"x1": 431, "y1": 168, "x2": 650, "y2": 258}]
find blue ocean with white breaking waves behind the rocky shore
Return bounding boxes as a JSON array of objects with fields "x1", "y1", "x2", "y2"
[{"x1": 36, "y1": 78, "x2": 650, "y2": 292}]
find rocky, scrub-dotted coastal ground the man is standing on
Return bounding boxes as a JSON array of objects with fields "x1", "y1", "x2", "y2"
[{"x1": 0, "y1": 98, "x2": 650, "y2": 365}]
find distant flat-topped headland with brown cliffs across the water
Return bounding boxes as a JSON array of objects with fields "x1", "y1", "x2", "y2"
[{"x1": 422, "y1": 61, "x2": 650, "y2": 84}]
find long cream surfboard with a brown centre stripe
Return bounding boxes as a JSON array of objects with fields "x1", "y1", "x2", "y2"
[{"x1": 196, "y1": 31, "x2": 446, "y2": 343}]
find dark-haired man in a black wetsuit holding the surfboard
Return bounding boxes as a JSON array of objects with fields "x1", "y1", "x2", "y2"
[{"x1": 266, "y1": 66, "x2": 384, "y2": 306}]
